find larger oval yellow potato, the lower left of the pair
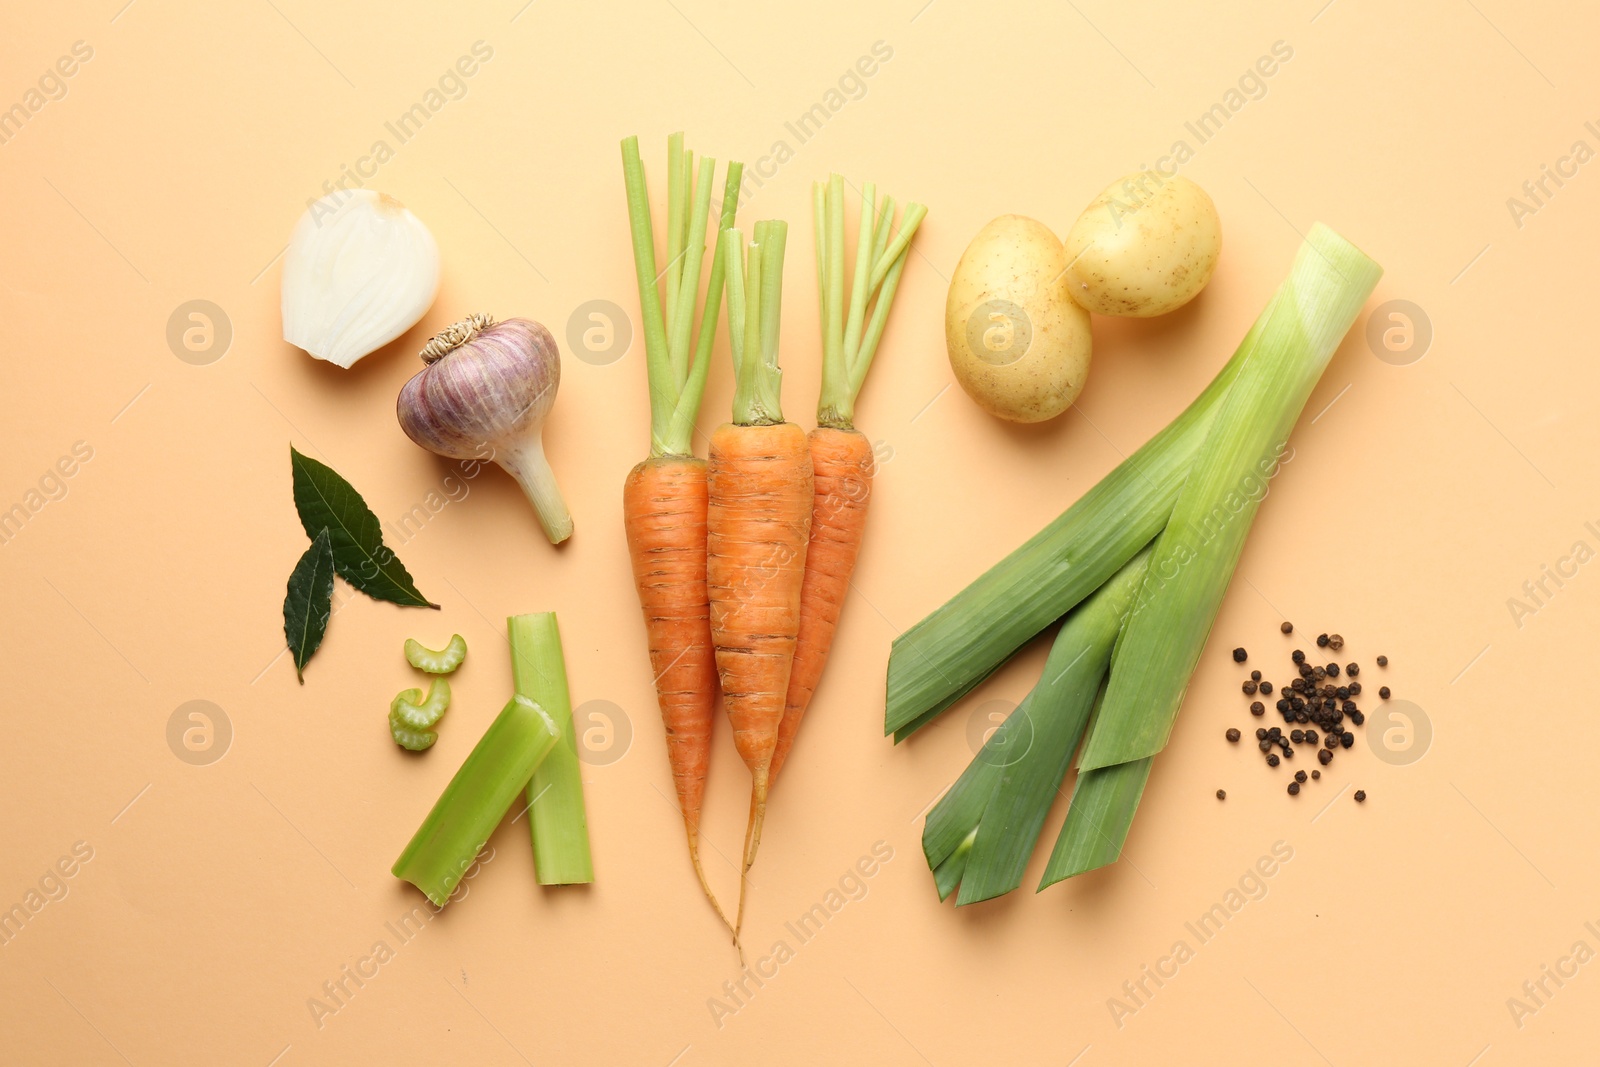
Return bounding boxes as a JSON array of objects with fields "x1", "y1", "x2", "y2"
[{"x1": 944, "y1": 214, "x2": 1090, "y2": 422}]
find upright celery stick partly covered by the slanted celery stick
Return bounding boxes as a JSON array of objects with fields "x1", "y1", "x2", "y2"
[{"x1": 506, "y1": 611, "x2": 595, "y2": 886}]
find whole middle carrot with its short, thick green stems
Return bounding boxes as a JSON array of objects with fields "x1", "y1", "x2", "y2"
[{"x1": 706, "y1": 222, "x2": 813, "y2": 936}]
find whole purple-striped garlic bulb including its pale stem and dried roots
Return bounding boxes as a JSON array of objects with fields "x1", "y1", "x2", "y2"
[{"x1": 395, "y1": 315, "x2": 573, "y2": 544}]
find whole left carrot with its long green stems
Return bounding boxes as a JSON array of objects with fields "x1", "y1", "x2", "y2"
[{"x1": 622, "y1": 133, "x2": 742, "y2": 944}]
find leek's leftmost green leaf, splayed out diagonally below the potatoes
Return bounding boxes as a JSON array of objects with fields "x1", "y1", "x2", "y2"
[{"x1": 883, "y1": 331, "x2": 1254, "y2": 742}]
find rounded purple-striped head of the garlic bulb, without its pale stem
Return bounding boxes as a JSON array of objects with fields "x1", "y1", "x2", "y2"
[{"x1": 397, "y1": 318, "x2": 562, "y2": 459}]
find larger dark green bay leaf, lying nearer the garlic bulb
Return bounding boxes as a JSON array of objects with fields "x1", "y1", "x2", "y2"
[{"x1": 290, "y1": 445, "x2": 438, "y2": 608}]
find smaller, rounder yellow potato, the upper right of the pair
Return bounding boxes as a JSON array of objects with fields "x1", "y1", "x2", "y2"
[{"x1": 1066, "y1": 171, "x2": 1222, "y2": 318}]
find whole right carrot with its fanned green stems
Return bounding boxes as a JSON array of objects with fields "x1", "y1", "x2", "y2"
[{"x1": 770, "y1": 174, "x2": 926, "y2": 779}]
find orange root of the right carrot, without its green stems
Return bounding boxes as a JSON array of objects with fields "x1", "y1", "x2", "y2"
[{"x1": 771, "y1": 426, "x2": 874, "y2": 781}]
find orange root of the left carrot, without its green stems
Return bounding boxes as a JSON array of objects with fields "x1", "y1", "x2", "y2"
[{"x1": 622, "y1": 456, "x2": 728, "y2": 923}]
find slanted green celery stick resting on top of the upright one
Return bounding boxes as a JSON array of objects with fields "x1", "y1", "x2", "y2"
[{"x1": 392, "y1": 696, "x2": 562, "y2": 907}]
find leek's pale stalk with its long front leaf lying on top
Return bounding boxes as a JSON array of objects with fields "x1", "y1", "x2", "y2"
[{"x1": 1080, "y1": 222, "x2": 1382, "y2": 771}]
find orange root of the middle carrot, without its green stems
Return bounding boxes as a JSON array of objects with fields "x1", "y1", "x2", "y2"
[{"x1": 706, "y1": 422, "x2": 813, "y2": 908}]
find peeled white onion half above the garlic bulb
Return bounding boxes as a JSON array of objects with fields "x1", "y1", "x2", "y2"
[{"x1": 283, "y1": 189, "x2": 438, "y2": 368}]
